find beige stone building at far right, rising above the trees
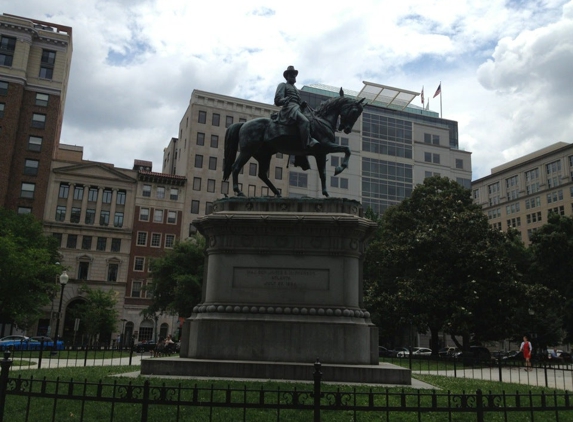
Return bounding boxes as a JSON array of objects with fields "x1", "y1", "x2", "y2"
[{"x1": 472, "y1": 142, "x2": 573, "y2": 244}]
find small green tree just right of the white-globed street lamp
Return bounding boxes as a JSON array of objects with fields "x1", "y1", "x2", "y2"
[{"x1": 74, "y1": 285, "x2": 119, "y2": 344}]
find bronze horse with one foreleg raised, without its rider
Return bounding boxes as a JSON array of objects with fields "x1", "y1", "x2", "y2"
[{"x1": 223, "y1": 88, "x2": 364, "y2": 197}]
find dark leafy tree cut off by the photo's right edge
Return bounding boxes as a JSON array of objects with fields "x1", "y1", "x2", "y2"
[{"x1": 529, "y1": 213, "x2": 573, "y2": 344}]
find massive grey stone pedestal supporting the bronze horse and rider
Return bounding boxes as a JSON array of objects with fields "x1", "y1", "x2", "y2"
[{"x1": 142, "y1": 198, "x2": 410, "y2": 384}]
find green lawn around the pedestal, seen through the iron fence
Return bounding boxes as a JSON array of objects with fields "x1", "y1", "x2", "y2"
[{"x1": 4, "y1": 366, "x2": 573, "y2": 422}]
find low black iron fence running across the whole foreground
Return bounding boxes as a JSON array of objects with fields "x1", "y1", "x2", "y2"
[{"x1": 0, "y1": 355, "x2": 573, "y2": 422}]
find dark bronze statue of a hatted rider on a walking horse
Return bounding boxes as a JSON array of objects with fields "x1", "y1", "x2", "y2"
[{"x1": 223, "y1": 66, "x2": 365, "y2": 197}]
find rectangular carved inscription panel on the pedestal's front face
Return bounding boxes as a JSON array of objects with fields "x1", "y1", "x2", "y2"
[{"x1": 233, "y1": 267, "x2": 329, "y2": 290}]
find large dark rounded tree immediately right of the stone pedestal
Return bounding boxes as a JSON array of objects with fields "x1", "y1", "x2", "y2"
[{"x1": 365, "y1": 177, "x2": 523, "y2": 352}]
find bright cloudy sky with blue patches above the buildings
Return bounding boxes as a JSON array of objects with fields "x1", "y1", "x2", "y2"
[{"x1": 4, "y1": 0, "x2": 573, "y2": 180}]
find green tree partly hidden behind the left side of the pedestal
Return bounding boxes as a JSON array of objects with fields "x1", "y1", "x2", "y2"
[{"x1": 145, "y1": 234, "x2": 205, "y2": 317}]
